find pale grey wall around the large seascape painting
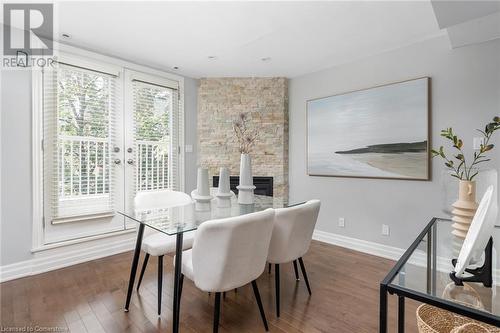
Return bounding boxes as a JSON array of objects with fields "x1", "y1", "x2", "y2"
[{"x1": 289, "y1": 36, "x2": 500, "y2": 248}]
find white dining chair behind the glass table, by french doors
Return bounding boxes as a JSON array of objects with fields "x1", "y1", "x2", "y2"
[{"x1": 134, "y1": 190, "x2": 194, "y2": 315}]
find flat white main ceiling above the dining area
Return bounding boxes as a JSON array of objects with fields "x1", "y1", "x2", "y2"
[{"x1": 56, "y1": 1, "x2": 440, "y2": 77}]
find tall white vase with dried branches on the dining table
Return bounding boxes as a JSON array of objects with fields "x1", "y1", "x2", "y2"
[{"x1": 233, "y1": 113, "x2": 259, "y2": 204}]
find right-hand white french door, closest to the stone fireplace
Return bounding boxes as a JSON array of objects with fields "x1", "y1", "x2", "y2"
[{"x1": 125, "y1": 70, "x2": 182, "y2": 229}]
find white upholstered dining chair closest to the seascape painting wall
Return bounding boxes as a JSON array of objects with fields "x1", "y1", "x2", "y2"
[{"x1": 267, "y1": 200, "x2": 321, "y2": 317}]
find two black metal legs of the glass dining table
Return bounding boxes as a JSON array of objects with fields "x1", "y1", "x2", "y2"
[{"x1": 125, "y1": 222, "x2": 189, "y2": 333}]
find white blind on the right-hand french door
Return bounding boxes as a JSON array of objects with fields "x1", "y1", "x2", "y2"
[{"x1": 132, "y1": 80, "x2": 181, "y2": 192}]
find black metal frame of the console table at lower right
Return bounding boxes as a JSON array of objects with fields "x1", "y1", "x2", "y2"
[{"x1": 379, "y1": 217, "x2": 500, "y2": 333}]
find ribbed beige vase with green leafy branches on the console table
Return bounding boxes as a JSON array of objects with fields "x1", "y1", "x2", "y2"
[{"x1": 431, "y1": 117, "x2": 500, "y2": 238}]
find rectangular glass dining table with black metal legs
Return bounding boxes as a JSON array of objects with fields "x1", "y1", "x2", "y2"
[{"x1": 118, "y1": 195, "x2": 289, "y2": 333}]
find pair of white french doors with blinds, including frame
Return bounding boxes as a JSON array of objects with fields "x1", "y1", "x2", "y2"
[{"x1": 42, "y1": 56, "x2": 182, "y2": 244}]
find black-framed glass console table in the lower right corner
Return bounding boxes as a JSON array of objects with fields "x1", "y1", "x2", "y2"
[{"x1": 379, "y1": 218, "x2": 500, "y2": 333}]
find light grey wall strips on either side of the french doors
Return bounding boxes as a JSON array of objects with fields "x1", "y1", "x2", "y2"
[{"x1": 0, "y1": 70, "x2": 197, "y2": 266}]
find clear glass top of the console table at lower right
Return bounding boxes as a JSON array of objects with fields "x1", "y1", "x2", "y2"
[{"x1": 388, "y1": 219, "x2": 500, "y2": 316}]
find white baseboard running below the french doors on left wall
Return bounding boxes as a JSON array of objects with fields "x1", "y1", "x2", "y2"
[{"x1": 0, "y1": 233, "x2": 136, "y2": 282}]
